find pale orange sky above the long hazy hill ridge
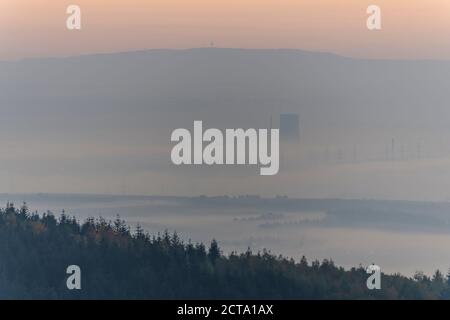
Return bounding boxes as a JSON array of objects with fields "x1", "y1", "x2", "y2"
[{"x1": 0, "y1": 0, "x2": 450, "y2": 59}]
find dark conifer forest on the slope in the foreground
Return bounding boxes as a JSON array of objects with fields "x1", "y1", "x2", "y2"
[{"x1": 0, "y1": 204, "x2": 450, "y2": 299}]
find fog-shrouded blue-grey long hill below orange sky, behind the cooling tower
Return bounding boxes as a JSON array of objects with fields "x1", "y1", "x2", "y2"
[{"x1": 0, "y1": 49, "x2": 450, "y2": 200}]
